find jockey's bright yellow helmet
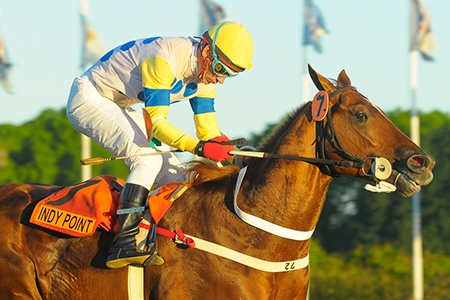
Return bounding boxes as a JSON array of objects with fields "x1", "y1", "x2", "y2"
[{"x1": 203, "y1": 22, "x2": 253, "y2": 72}]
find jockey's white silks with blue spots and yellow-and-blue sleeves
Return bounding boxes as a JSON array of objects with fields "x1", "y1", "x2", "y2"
[{"x1": 85, "y1": 37, "x2": 220, "y2": 152}]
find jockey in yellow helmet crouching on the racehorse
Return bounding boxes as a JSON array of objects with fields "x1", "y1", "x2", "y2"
[{"x1": 66, "y1": 22, "x2": 253, "y2": 268}]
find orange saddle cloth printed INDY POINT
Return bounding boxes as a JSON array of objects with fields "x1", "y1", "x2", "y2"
[{"x1": 30, "y1": 175, "x2": 180, "y2": 237}]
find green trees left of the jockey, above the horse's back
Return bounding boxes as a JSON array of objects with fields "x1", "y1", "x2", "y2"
[{"x1": 0, "y1": 109, "x2": 129, "y2": 186}]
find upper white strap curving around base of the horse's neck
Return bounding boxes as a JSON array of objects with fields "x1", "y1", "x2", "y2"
[{"x1": 234, "y1": 167, "x2": 314, "y2": 241}]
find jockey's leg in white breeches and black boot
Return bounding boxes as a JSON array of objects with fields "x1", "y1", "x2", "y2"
[{"x1": 67, "y1": 76, "x2": 163, "y2": 268}]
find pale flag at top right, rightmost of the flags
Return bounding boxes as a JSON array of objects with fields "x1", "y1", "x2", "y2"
[{"x1": 410, "y1": 0, "x2": 436, "y2": 61}]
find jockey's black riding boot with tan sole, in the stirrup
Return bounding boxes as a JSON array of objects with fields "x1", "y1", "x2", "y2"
[{"x1": 106, "y1": 183, "x2": 164, "y2": 269}]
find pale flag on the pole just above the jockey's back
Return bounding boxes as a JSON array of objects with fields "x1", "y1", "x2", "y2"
[{"x1": 80, "y1": 0, "x2": 105, "y2": 69}]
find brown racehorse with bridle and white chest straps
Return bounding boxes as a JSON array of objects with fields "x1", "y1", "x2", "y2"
[{"x1": 0, "y1": 67, "x2": 435, "y2": 300}]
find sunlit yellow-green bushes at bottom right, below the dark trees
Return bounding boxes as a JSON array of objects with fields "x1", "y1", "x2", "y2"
[{"x1": 310, "y1": 239, "x2": 450, "y2": 300}]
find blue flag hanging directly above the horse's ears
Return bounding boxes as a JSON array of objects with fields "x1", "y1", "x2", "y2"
[{"x1": 303, "y1": 0, "x2": 328, "y2": 53}]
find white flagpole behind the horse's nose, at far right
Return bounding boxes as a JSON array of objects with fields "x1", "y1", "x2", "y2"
[{"x1": 409, "y1": 50, "x2": 424, "y2": 300}]
